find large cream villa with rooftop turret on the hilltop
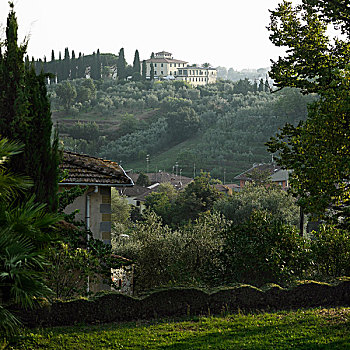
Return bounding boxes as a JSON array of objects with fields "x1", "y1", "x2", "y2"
[{"x1": 146, "y1": 51, "x2": 217, "y2": 86}]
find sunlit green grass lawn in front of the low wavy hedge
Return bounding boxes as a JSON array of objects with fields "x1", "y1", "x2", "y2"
[{"x1": 9, "y1": 308, "x2": 350, "y2": 350}]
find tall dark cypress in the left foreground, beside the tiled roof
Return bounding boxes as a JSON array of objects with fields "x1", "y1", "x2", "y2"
[{"x1": 0, "y1": 4, "x2": 59, "y2": 211}]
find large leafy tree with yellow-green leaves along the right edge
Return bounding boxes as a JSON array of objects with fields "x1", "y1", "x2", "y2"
[{"x1": 268, "y1": 0, "x2": 350, "y2": 223}]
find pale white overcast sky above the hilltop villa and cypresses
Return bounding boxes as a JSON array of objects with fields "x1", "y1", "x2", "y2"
[{"x1": 0, "y1": 0, "x2": 297, "y2": 70}]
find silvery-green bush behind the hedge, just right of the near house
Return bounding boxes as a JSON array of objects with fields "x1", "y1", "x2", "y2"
[{"x1": 116, "y1": 212, "x2": 227, "y2": 290}]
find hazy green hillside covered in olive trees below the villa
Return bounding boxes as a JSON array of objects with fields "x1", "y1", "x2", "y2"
[{"x1": 50, "y1": 79, "x2": 315, "y2": 181}]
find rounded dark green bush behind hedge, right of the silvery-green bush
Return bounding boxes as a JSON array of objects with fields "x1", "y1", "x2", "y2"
[{"x1": 222, "y1": 211, "x2": 310, "y2": 285}]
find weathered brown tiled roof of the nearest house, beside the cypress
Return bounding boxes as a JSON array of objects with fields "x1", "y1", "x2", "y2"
[{"x1": 60, "y1": 151, "x2": 133, "y2": 186}]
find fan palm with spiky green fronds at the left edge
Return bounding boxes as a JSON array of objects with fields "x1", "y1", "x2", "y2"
[{"x1": 0, "y1": 139, "x2": 58, "y2": 335}]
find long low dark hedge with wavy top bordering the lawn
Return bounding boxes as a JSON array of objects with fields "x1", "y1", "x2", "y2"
[{"x1": 14, "y1": 281, "x2": 350, "y2": 327}]
